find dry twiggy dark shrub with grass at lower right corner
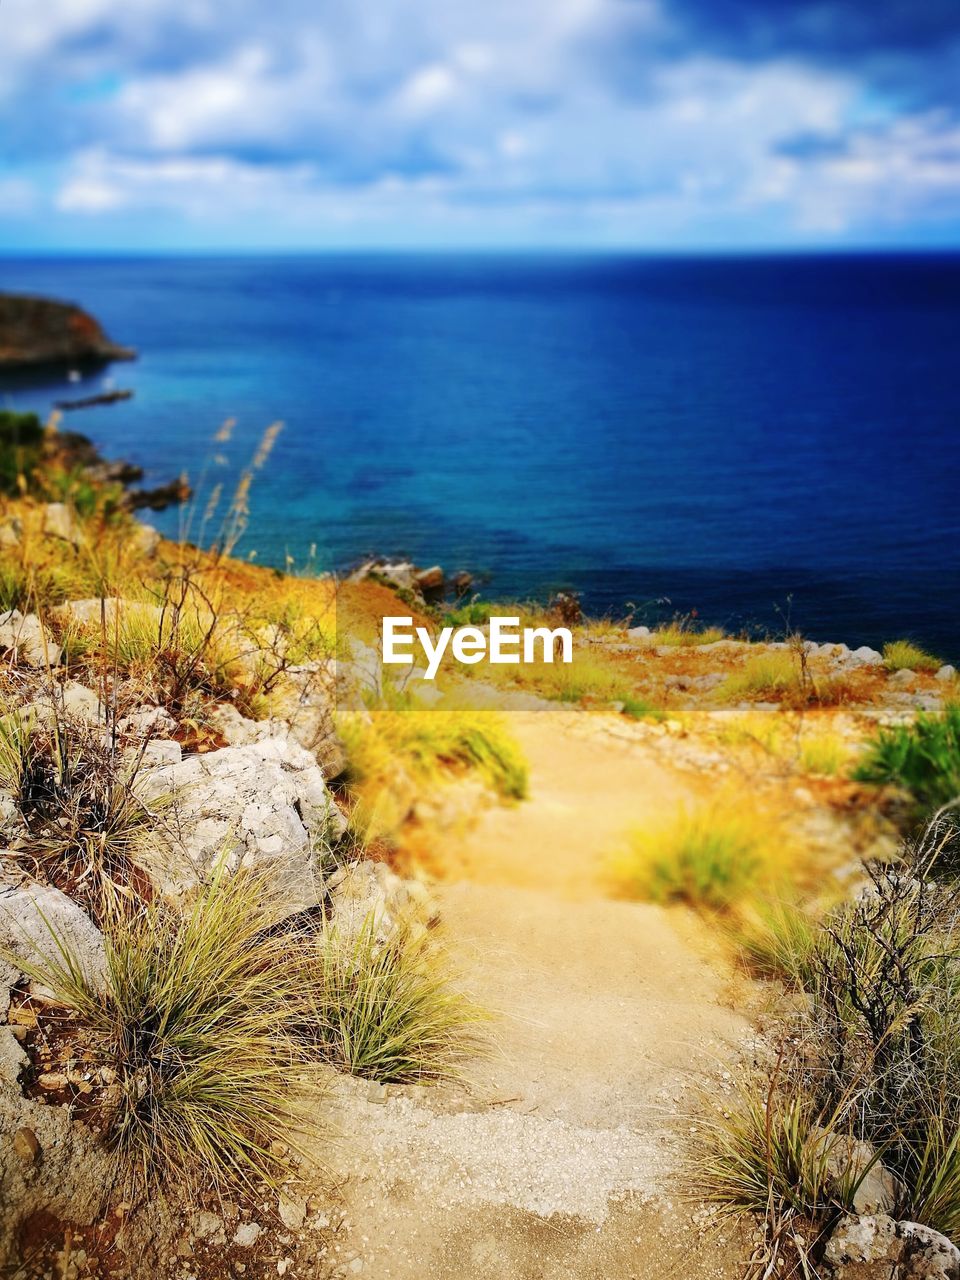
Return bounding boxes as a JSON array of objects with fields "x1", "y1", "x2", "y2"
[{"x1": 699, "y1": 820, "x2": 960, "y2": 1252}]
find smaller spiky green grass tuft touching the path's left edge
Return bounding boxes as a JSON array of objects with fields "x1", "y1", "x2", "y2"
[{"x1": 301, "y1": 915, "x2": 481, "y2": 1084}]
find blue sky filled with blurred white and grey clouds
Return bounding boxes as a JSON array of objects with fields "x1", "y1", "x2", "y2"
[{"x1": 0, "y1": 0, "x2": 960, "y2": 252}]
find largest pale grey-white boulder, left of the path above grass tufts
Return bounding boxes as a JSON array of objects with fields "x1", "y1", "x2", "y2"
[{"x1": 137, "y1": 737, "x2": 346, "y2": 911}]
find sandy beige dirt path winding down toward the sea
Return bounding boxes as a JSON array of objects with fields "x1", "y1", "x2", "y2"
[{"x1": 328, "y1": 713, "x2": 749, "y2": 1280}]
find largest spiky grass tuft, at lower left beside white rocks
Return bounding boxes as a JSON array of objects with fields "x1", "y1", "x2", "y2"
[{"x1": 8, "y1": 873, "x2": 316, "y2": 1192}]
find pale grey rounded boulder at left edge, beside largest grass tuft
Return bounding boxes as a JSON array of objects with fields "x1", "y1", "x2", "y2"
[{"x1": 0, "y1": 884, "x2": 106, "y2": 987}]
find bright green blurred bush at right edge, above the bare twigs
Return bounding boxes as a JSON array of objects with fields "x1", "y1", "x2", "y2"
[{"x1": 854, "y1": 705, "x2": 960, "y2": 814}]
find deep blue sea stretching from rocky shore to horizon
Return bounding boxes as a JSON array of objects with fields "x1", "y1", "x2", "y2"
[{"x1": 0, "y1": 255, "x2": 960, "y2": 659}]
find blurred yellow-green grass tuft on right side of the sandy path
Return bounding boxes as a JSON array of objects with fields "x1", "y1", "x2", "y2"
[{"x1": 621, "y1": 809, "x2": 767, "y2": 911}]
